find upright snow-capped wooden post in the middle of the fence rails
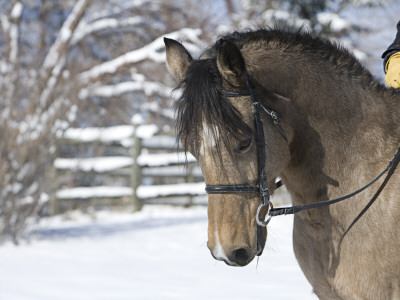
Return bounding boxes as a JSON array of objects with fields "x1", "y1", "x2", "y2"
[{"x1": 131, "y1": 115, "x2": 143, "y2": 211}]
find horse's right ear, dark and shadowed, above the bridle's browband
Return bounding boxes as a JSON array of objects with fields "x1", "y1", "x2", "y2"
[{"x1": 217, "y1": 39, "x2": 246, "y2": 84}]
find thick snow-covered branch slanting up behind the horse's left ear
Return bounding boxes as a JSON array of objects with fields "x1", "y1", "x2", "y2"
[{"x1": 80, "y1": 28, "x2": 202, "y2": 82}]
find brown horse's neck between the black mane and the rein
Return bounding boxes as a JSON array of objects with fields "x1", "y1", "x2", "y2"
[{"x1": 250, "y1": 51, "x2": 400, "y2": 204}]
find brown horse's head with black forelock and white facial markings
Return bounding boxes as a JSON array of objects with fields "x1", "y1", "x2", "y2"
[{"x1": 165, "y1": 39, "x2": 291, "y2": 266}]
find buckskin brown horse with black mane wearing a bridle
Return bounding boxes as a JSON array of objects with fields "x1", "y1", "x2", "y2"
[{"x1": 164, "y1": 28, "x2": 400, "y2": 299}]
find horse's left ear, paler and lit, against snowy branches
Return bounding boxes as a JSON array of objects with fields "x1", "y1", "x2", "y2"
[{"x1": 164, "y1": 38, "x2": 193, "y2": 80}]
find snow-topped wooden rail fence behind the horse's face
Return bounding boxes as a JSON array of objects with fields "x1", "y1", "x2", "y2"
[{"x1": 50, "y1": 123, "x2": 205, "y2": 214}]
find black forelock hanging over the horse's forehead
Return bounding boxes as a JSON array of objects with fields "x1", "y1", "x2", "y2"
[{"x1": 176, "y1": 58, "x2": 251, "y2": 156}]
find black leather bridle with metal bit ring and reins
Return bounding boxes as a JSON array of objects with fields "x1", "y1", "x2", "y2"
[{"x1": 205, "y1": 75, "x2": 400, "y2": 229}]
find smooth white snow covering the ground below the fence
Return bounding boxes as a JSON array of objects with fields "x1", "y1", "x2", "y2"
[{"x1": 0, "y1": 206, "x2": 317, "y2": 300}]
